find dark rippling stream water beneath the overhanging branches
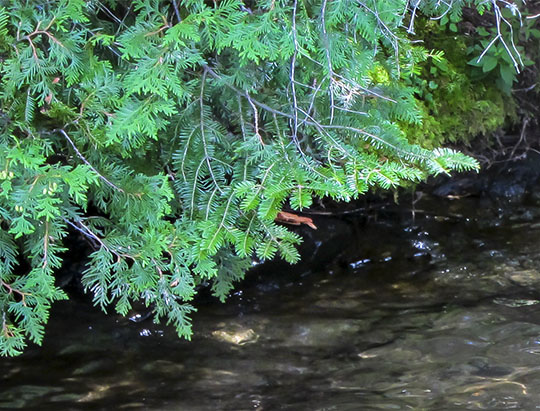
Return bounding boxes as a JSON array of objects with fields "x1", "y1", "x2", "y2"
[{"x1": 0, "y1": 198, "x2": 540, "y2": 410}]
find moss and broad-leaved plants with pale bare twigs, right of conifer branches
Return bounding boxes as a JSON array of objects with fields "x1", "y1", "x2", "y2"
[{"x1": 402, "y1": 2, "x2": 540, "y2": 148}]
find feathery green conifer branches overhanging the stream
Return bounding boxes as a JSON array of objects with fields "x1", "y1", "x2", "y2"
[{"x1": 0, "y1": 0, "x2": 512, "y2": 355}]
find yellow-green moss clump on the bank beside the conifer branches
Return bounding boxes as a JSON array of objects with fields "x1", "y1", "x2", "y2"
[{"x1": 403, "y1": 20, "x2": 516, "y2": 147}]
